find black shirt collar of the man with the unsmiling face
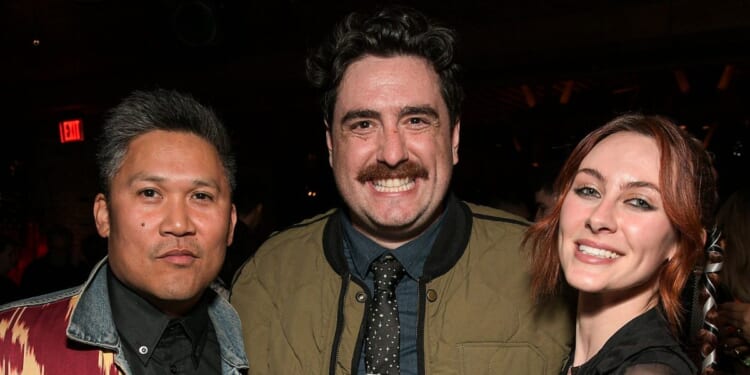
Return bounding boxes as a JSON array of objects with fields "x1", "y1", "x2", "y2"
[{"x1": 107, "y1": 272, "x2": 215, "y2": 364}]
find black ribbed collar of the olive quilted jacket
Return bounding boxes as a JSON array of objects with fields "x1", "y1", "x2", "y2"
[{"x1": 323, "y1": 194, "x2": 472, "y2": 282}]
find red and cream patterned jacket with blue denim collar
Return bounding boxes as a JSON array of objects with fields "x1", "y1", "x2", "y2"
[{"x1": 0, "y1": 258, "x2": 248, "y2": 375}]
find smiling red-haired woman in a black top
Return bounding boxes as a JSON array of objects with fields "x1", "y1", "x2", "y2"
[{"x1": 526, "y1": 114, "x2": 716, "y2": 375}]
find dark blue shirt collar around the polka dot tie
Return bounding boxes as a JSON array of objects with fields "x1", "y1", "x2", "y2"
[{"x1": 342, "y1": 212, "x2": 445, "y2": 280}]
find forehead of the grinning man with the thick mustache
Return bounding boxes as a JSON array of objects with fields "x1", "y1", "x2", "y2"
[{"x1": 335, "y1": 55, "x2": 445, "y2": 110}]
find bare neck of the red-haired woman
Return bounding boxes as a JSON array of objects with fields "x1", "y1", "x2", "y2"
[{"x1": 573, "y1": 288, "x2": 658, "y2": 366}]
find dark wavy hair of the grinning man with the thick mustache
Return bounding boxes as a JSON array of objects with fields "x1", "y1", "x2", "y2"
[{"x1": 306, "y1": 6, "x2": 464, "y2": 126}]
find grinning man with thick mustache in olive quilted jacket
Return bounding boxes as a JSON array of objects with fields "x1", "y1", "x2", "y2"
[{"x1": 231, "y1": 7, "x2": 572, "y2": 375}]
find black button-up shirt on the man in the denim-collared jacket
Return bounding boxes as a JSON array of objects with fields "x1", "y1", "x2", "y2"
[{"x1": 108, "y1": 272, "x2": 221, "y2": 375}]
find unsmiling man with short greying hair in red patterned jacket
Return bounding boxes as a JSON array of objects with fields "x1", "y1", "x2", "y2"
[{"x1": 0, "y1": 89, "x2": 253, "y2": 374}]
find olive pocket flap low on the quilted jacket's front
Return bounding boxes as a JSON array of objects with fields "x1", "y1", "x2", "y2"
[{"x1": 458, "y1": 342, "x2": 547, "y2": 375}]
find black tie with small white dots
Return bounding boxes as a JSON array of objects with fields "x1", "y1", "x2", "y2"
[{"x1": 365, "y1": 254, "x2": 404, "y2": 375}]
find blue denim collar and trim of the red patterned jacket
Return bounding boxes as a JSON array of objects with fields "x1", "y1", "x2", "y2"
[{"x1": 3, "y1": 257, "x2": 248, "y2": 375}]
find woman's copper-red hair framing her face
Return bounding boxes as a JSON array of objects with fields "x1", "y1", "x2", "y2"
[{"x1": 524, "y1": 114, "x2": 718, "y2": 332}]
